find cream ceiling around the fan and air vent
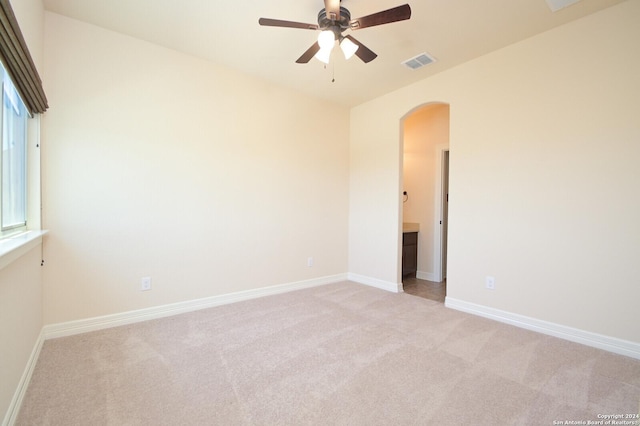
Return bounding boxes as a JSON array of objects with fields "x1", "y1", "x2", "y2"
[{"x1": 44, "y1": 0, "x2": 625, "y2": 106}]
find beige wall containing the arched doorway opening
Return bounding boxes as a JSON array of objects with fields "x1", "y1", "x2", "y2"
[{"x1": 349, "y1": 2, "x2": 640, "y2": 342}]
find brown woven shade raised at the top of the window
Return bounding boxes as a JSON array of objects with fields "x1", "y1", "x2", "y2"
[{"x1": 0, "y1": 0, "x2": 49, "y2": 114}]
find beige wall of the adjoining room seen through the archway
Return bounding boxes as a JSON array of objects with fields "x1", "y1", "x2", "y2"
[{"x1": 401, "y1": 103, "x2": 449, "y2": 281}]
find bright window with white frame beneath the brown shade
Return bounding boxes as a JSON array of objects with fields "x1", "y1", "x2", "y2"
[{"x1": 0, "y1": 67, "x2": 28, "y2": 235}]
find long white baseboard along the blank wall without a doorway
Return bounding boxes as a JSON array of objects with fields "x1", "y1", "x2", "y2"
[{"x1": 42, "y1": 274, "x2": 347, "y2": 339}]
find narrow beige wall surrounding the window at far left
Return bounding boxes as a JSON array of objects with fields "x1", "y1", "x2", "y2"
[{"x1": 0, "y1": 0, "x2": 44, "y2": 420}]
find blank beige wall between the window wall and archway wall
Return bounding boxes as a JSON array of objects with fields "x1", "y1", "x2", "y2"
[{"x1": 43, "y1": 13, "x2": 349, "y2": 324}]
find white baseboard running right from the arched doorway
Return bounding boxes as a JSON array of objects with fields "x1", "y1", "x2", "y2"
[{"x1": 445, "y1": 297, "x2": 640, "y2": 359}]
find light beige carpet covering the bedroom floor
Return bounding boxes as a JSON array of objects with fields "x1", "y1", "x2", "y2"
[{"x1": 17, "y1": 282, "x2": 640, "y2": 425}]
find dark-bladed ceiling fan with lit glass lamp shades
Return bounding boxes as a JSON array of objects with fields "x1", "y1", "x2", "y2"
[{"x1": 258, "y1": 0, "x2": 411, "y2": 64}]
